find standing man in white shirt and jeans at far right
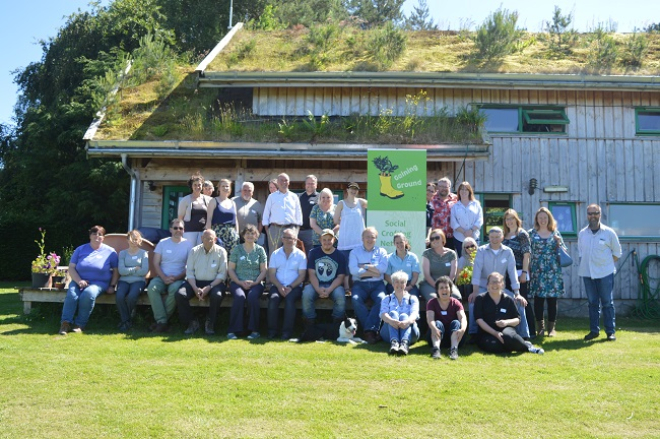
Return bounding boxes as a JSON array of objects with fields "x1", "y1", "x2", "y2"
[{"x1": 578, "y1": 204, "x2": 621, "y2": 341}]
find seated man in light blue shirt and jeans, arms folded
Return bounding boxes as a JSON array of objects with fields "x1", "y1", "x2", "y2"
[{"x1": 348, "y1": 227, "x2": 387, "y2": 344}]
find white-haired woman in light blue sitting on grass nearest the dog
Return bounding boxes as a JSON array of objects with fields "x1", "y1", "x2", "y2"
[{"x1": 380, "y1": 271, "x2": 419, "y2": 355}]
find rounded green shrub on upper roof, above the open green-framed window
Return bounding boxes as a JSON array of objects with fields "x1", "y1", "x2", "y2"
[{"x1": 474, "y1": 9, "x2": 522, "y2": 60}]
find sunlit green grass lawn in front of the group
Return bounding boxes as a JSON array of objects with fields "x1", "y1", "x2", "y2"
[{"x1": 0, "y1": 283, "x2": 660, "y2": 438}]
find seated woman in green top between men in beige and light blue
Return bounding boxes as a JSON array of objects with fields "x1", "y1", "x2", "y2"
[{"x1": 227, "y1": 224, "x2": 268, "y2": 340}]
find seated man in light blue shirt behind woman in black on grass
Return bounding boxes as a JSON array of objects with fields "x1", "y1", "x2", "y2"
[{"x1": 468, "y1": 227, "x2": 529, "y2": 343}]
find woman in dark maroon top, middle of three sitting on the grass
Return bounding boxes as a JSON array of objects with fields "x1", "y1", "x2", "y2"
[{"x1": 426, "y1": 276, "x2": 467, "y2": 360}]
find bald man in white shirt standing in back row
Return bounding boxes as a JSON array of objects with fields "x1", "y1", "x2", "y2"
[{"x1": 262, "y1": 173, "x2": 302, "y2": 259}]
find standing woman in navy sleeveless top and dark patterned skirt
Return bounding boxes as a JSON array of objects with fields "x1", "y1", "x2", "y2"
[{"x1": 206, "y1": 178, "x2": 239, "y2": 255}]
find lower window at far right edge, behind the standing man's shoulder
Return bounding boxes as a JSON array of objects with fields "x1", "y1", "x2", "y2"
[{"x1": 603, "y1": 204, "x2": 660, "y2": 240}]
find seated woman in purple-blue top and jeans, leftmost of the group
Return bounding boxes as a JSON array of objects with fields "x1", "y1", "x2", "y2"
[{"x1": 59, "y1": 226, "x2": 119, "y2": 335}]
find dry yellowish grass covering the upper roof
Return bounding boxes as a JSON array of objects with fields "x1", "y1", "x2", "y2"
[{"x1": 207, "y1": 27, "x2": 660, "y2": 75}]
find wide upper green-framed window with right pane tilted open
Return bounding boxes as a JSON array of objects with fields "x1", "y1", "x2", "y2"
[{"x1": 479, "y1": 105, "x2": 570, "y2": 134}]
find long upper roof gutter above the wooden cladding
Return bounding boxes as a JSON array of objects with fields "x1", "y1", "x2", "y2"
[{"x1": 198, "y1": 72, "x2": 660, "y2": 91}]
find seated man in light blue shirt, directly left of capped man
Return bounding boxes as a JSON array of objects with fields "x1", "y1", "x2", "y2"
[{"x1": 268, "y1": 228, "x2": 307, "y2": 340}]
